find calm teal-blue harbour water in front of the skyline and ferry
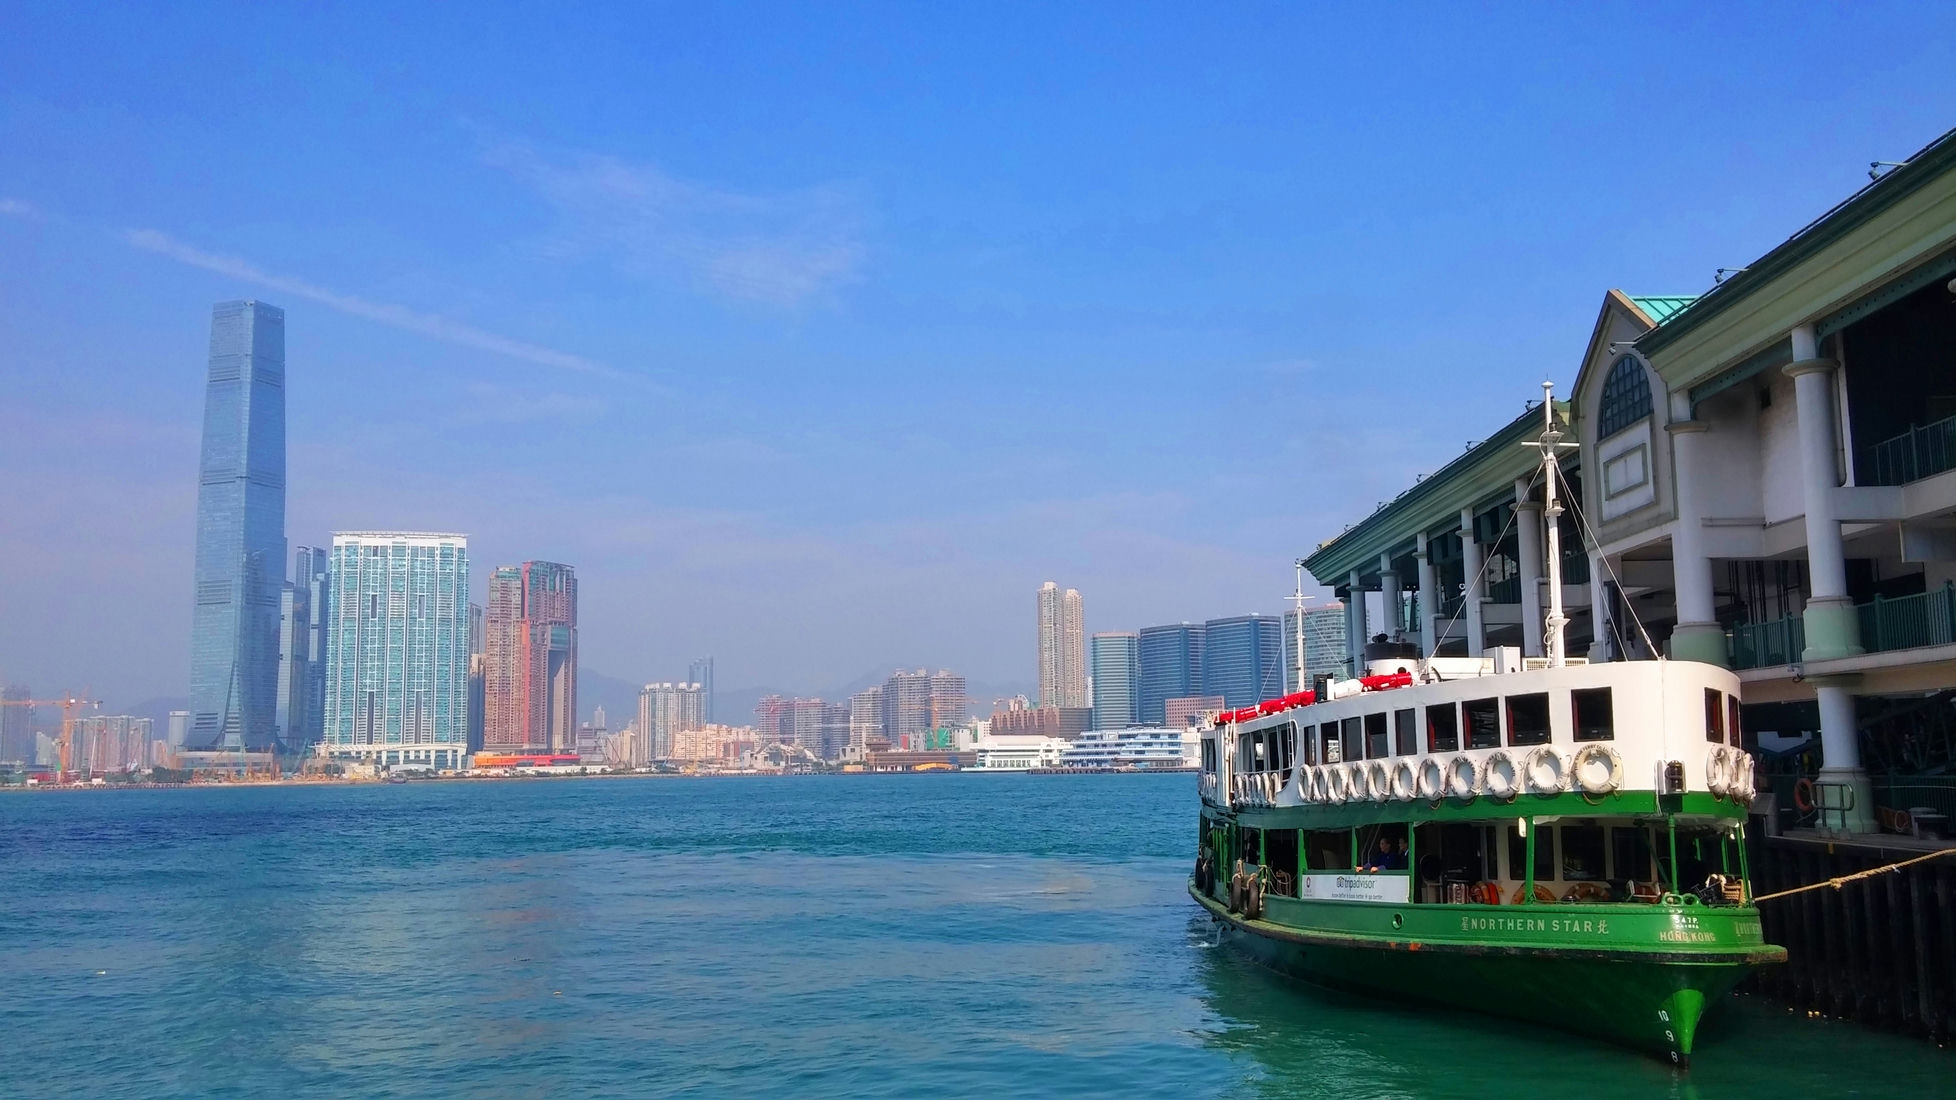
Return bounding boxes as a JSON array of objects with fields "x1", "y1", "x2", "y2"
[{"x1": 0, "y1": 775, "x2": 1956, "y2": 1100}]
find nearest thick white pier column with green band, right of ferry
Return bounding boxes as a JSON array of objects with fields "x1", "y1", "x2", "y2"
[{"x1": 1786, "y1": 325, "x2": 1874, "y2": 832}]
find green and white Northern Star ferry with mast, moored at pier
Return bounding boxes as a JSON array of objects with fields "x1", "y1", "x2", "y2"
[{"x1": 1189, "y1": 389, "x2": 1786, "y2": 1067}]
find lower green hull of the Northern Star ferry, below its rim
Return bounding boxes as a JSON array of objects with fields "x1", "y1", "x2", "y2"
[{"x1": 1189, "y1": 881, "x2": 1786, "y2": 1067}]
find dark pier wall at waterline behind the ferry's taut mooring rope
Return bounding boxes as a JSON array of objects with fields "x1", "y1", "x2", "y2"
[{"x1": 1745, "y1": 830, "x2": 1956, "y2": 1045}]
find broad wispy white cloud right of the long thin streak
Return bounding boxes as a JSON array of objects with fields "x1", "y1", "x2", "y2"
[{"x1": 485, "y1": 143, "x2": 865, "y2": 307}]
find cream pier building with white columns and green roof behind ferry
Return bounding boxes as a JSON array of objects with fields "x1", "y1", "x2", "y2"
[{"x1": 1307, "y1": 121, "x2": 1956, "y2": 832}]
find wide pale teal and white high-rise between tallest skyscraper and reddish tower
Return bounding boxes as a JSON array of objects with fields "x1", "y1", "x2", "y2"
[{"x1": 321, "y1": 530, "x2": 469, "y2": 767}]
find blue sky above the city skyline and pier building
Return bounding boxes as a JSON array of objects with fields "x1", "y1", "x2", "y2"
[{"x1": 0, "y1": 4, "x2": 1956, "y2": 703}]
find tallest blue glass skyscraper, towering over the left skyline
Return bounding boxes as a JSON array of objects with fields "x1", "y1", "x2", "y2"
[{"x1": 186, "y1": 301, "x2": 286, "y2": 750}]
